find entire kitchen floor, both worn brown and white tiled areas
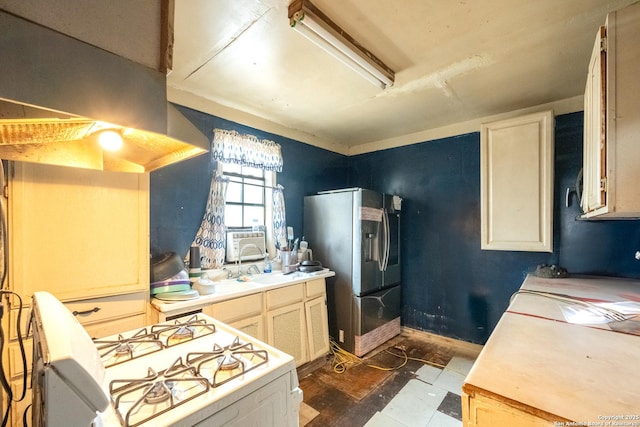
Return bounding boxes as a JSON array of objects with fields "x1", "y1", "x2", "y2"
[{"x1": 299, "y1": 333, "x2": 479, "y2": 427}]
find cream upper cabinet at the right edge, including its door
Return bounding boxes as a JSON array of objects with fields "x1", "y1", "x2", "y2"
[{"x1": 581, "y1": 3, "x2": 640, "y2": 219}]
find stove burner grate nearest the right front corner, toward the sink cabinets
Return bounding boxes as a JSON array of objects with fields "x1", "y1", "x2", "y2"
[{"x1": 187, "y1": 337, "x2": 269, "y2": 387}]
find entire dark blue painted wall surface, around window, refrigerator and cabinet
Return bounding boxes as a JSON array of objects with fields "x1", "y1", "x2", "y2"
[{"x1": 151, "y1": 109, "x2": 640, "y2": 343}]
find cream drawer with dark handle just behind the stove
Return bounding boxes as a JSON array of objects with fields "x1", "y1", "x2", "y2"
[{"x1": 64, "y1": 292, "x2": 147, "y2": 325}]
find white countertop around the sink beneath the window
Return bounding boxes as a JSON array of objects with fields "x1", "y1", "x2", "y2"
[{"x1": 151, "y1": 269, "x2": 336, "y2": 313}]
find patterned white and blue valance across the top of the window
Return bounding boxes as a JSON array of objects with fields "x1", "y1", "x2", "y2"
[{"x1": 211, "y1": 129, "x2": 282, "y2": 172}]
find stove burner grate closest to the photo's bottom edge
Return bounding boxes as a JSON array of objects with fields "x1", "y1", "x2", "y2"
[{"x1": 109, "y1": 357, "x2": 211, "y2": 427}]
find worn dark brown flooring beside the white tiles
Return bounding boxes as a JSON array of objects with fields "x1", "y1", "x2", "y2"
[{"x1": 298, "y1": 332, "x2": 478, "y2": 427}]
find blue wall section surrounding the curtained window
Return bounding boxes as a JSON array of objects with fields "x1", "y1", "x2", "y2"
[{"x1": 150, "y1": 106, "x2": 348, "y2": 257}]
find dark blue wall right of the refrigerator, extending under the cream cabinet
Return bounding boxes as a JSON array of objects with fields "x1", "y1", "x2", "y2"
[{"x1": 353, "y1": 133, "x2": 556, "y2": 343}]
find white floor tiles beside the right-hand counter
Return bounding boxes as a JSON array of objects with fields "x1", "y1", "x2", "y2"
[{"x1": 365, "y1": 356, "x2": 473, "y2": 427}]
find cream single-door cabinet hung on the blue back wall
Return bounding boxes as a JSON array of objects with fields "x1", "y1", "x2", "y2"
[{"x1": 480, "y1": 111, "x2": 554, "y2": 252}]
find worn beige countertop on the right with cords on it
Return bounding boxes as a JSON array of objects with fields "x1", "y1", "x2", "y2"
[{"x1": 463, "y1": 275, "x2": 640, "y2": 425}]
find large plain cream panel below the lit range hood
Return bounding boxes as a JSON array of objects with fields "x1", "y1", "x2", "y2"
[{"x1": 9, "y1": 162, "x2": 149, "y2": 300}]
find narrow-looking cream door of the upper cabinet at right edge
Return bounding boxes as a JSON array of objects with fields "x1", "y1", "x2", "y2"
[{"x1": 580, "y1": 27, "x2": 607, "y2": 212}]
